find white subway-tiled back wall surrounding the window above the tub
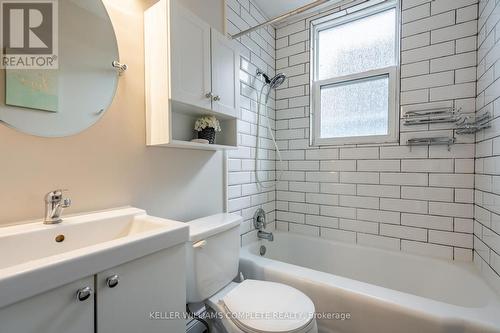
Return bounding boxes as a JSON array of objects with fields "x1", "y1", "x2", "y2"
[{"x1": 275, "y1": 0, "x2": 476, "y2": 260}]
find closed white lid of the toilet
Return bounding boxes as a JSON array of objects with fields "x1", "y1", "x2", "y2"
[{"x1": 222, "y1": 280, "x2": 314, "y2": 333}]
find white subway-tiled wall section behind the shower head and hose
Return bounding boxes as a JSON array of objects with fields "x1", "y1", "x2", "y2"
[{"x1": 226, "y1": 0, "x2": 278, "y2": 242}]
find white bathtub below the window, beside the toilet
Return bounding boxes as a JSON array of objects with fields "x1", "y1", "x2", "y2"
[{"x1": 240, "y1": 232, "x2": 500, "y2": 333}]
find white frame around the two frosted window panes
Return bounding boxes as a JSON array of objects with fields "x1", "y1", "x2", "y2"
[{"x1": 310, "y1": 0, "x2": 401, "y2": 146}]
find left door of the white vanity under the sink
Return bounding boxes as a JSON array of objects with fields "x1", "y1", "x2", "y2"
[{"x1": 0, "y1": 276, "x2": 94, "y2": 333}]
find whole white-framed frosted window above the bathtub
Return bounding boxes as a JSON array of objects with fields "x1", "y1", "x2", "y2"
[{"x1": 311, "y1": 1, "x2": 399, "y2": 145}]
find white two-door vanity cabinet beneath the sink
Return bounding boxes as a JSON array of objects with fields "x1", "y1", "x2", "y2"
[{"x1": 0, "y1": 244, "x2": 186, "y2": 333}]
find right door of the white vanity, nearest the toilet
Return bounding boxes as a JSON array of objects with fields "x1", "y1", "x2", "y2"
[{"x1": 96, "y1": 244, "x2": 186, "y2": 333}]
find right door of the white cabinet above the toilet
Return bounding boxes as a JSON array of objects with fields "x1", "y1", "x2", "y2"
[{"x1": 212, "y1": 29, "x2": 240, "y2": 117}]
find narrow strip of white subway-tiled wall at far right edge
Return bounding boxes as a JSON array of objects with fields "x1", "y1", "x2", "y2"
[{"x1": 472, "y1": 0, "x2": 500, "y2": 291}]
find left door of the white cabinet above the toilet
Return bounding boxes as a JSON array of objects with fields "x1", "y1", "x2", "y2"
[{"x1": 171, "y1": 1, "x2": 212, "y2": 109}]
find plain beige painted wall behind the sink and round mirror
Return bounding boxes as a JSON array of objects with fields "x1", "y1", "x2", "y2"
[{"x1": 0, "y1": 0, "x2": 223, "y2": 225}]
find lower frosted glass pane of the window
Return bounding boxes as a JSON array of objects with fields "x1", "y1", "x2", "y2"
[{"x1": 320, "y1": 75, "x2": 389, "y2": 138}]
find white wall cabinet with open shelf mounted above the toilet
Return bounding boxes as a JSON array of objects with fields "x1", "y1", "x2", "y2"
[{"x1": 144, "y1": 0, "x2": 240, "y2": 150}]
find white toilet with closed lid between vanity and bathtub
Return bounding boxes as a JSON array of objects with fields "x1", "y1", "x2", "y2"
[{"x1": 187, "y1": 214, "x2": 318, "y2": 333}]
